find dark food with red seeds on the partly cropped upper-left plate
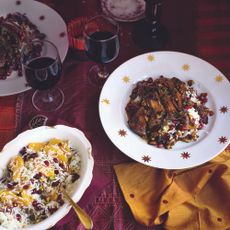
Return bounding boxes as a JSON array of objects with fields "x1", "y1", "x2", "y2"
[{"x1": 0, "y1": 12, "x2": 45, "y2": 80}]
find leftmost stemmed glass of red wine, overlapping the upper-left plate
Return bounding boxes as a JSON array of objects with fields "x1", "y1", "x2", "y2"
[{"x1": 21, "y1": 40, "x2": 64, "y2": 112}]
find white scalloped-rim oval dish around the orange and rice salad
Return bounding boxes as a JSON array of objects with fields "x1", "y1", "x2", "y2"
[{"x1": 0, "y1": 125, "x2": 94, "y2": 230}]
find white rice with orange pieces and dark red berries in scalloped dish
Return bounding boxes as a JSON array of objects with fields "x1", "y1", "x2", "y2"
[{"x1": 0, "y1": 138, "x2": 81, "y2": 229}]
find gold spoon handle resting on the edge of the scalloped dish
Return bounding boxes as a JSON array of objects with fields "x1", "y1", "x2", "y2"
[{"x1": 62, "y1": 188, "x2": 93, "y2": 229}]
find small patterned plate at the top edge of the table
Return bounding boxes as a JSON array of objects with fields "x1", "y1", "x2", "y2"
[{"x1": 101, "y1": 0, "x2": 145, "y2": 22}]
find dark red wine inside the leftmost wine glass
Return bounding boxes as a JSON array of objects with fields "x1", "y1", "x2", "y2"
[{"x1": 25, "y1": 57, "x2": 62, "y2": 90}]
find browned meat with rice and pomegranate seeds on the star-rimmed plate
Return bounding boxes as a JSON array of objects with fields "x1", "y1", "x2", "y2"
[{"x1": 125, "y1": 76, "x2": 213, "y2": 149}]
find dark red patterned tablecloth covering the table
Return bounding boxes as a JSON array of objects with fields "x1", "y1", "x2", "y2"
[{"x1": 0, "y1": 0, "x2": 230, "y2": 230}]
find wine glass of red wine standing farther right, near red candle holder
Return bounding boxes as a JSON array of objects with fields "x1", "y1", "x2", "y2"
[{"x1": 84, "y1": 15, "x2": 120, "y2": 86}]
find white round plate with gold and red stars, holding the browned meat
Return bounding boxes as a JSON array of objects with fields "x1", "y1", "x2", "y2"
[{"x1": 99, "y1": 51, "x2": 230, "y2": 169}]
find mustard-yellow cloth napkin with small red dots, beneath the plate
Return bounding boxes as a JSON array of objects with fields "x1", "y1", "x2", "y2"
[{"x1": 114, "y1": 149, "x2": 230, "y2": 230}]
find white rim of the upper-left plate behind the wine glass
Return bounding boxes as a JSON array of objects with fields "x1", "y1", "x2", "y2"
[{"x1": 0, "y1": 0, "x2": 69, "y2": 96}]
